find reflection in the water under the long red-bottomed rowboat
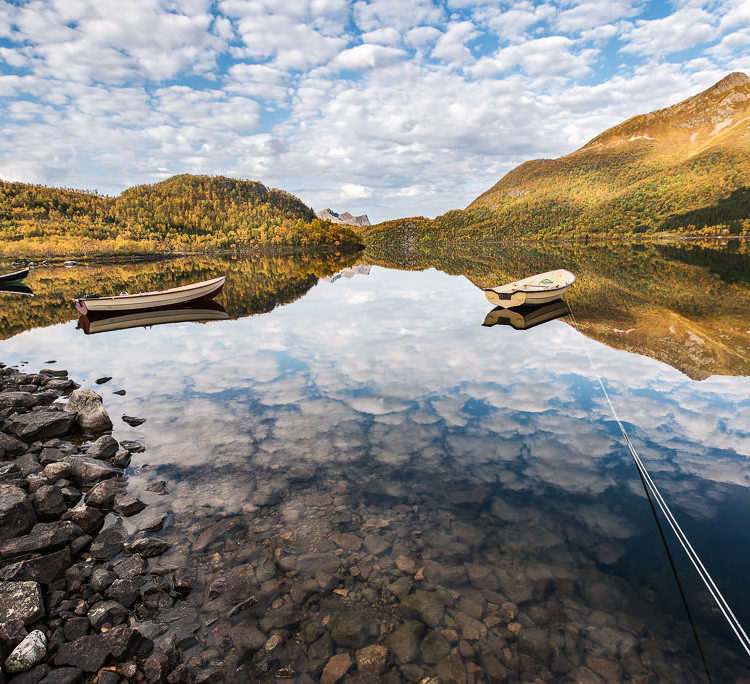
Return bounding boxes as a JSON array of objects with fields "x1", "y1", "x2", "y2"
[{"x1": 78, "y1": 302, "x2": 229, "y2": 335}]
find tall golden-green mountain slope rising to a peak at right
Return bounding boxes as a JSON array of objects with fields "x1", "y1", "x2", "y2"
[{"x1": 364, "y1": 73, "x2": 750, "y2": 243}]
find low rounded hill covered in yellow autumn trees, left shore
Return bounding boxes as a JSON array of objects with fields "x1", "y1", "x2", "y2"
[{"x1": 0, "y1": 174, "x2": 358, "y2": 255}]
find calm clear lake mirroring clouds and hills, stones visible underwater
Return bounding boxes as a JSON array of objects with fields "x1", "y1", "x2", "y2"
[{"x1": 0, "y1": 242, "x2": 750, "y2": 682}]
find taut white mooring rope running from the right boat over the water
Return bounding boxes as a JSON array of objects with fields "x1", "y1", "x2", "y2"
[{"x1": 568, "y1": 305, "x2": 750, "y2": 656}]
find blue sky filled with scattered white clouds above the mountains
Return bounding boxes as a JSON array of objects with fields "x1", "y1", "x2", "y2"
[{"x1": 0, "y1": 0, "x2": 750, "y2": 222}]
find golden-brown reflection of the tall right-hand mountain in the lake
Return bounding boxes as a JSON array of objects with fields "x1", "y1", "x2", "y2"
[{"x1": 361, "y1": 243, "x2": 750, "y2": 380}]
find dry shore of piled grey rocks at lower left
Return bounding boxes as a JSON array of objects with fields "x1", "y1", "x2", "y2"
[{"x1": 0, "y1": 364, "x2": 188, "y2": 684}]
